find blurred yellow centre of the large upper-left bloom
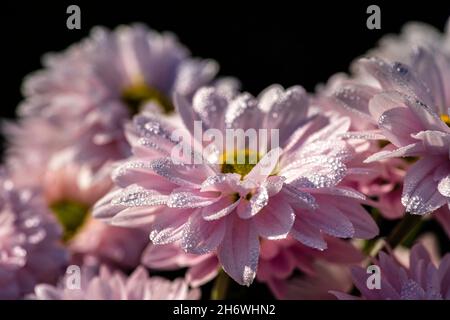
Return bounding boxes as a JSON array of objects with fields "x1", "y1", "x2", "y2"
[{"x1": 122, "y1": 80, "x2": 175, "y2": 114}]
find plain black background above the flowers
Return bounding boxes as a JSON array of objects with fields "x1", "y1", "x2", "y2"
[{"x1": 0, "y1": 0, "x2": 450, "y2": 117}]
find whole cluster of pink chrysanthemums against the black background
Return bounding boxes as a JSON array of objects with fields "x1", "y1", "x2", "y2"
[{"x1": 0, "y1": 23, "x2": 450, "y2": 300}]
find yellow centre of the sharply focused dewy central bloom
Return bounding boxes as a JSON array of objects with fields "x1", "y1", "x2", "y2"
[{"x1": 220, "y1": 149, "x2": 261, "y2": 178}]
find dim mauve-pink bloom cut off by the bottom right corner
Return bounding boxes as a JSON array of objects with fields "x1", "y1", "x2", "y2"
[{"x1": 333, "y1": 244, "x2": 450, "y2": 300}]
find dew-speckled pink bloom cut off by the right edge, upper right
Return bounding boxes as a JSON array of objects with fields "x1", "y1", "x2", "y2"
[{"x1": 330, "y1": 25, "x2": 450, "y2": 231}]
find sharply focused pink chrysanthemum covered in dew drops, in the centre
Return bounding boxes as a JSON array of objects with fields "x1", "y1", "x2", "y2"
[{"x1": 94, "y1": 86, "x2": 378, "y2": 285}]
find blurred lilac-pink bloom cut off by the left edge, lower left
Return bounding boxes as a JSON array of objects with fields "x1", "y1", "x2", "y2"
[{"x1": 0, "y1": 173, "x2": 68, "y2": 299}]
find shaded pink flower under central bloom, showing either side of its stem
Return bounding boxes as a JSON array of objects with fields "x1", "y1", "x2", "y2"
[{"x1": 142, "y1": 236, "x2": 363, "y2": 299}]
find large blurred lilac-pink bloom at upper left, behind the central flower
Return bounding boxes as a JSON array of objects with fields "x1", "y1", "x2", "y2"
[{"x1": 6, "y1": 24, "x2": 229, "y2": 188}]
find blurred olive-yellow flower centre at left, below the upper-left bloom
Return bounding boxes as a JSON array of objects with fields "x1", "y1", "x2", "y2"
[{"x1": 50, "y1": 200, "x2": 89, "y2": 242}]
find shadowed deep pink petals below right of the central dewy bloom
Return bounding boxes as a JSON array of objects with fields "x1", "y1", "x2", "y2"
[{"x1": 256, "y1": 237, "x2": 364, "y2": 300}]
